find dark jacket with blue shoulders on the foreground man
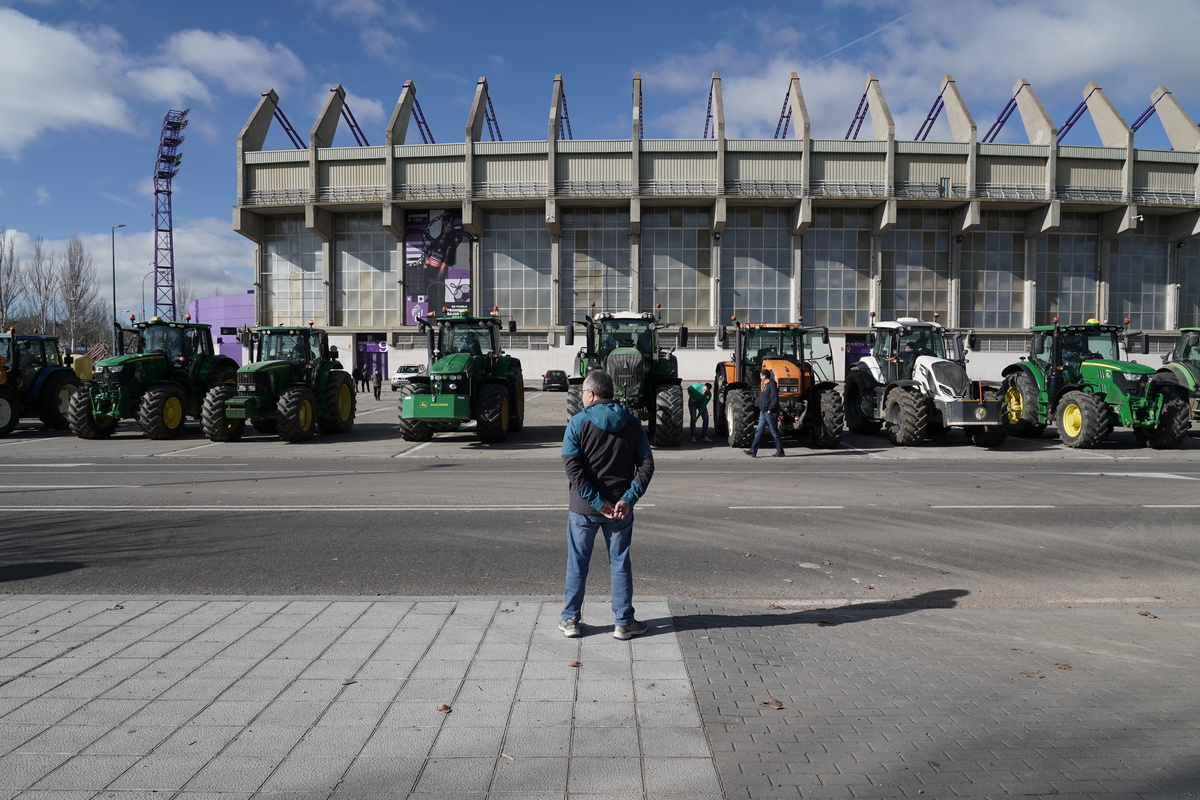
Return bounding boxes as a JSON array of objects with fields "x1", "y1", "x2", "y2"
[{"x1": 563, "y1": 402, "x2": 654, "y2": 515}]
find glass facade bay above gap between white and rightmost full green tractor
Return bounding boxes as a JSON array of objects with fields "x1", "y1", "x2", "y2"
[{"x1": 959, "y1": 211, "x2": 1026, "y2": 329}]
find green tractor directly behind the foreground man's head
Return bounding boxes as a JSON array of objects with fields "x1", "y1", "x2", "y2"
[{"x1": 564, "y1": 303, "x2": 688, "y2": 447}]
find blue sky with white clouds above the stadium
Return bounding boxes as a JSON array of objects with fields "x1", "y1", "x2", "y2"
[{"x1": 0, "y1": 0, "x2": 1200, "y2": 317}]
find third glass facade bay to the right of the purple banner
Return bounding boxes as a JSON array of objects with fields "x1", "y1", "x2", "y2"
[{"x1": 641, "y1": 206, "x2": 713, "y2": 326}]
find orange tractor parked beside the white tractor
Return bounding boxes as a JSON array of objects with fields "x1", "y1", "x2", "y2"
[{"x1": 713, "y1": 318, "x2": 845, "y2": 449}]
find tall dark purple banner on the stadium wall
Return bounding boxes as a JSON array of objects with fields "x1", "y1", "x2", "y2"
[{"x1": 404, "y1": 209, "x2": 470, "y2": 325}]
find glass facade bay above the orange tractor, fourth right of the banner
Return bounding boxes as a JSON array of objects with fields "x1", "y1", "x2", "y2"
[{"x1": 718, "y1": 207, "x2": 794, "y2": 324}]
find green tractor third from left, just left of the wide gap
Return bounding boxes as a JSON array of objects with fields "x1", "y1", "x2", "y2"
[{"x1": 200, "y1": 324, "x2": 358, "y2": 441}]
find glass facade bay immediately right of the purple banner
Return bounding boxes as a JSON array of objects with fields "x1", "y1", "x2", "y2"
[{"x1": 480, "y1": 209, "x2": 553, "y2": 327}]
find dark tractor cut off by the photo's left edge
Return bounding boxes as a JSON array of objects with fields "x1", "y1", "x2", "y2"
[{"x1": 0, "y1": 327, "x2": 83, "y2": 437}]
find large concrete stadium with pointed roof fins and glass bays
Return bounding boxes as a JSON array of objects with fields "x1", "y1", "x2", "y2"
[{"x1": 234, "y1": 73, "x2": 1200, "y2": 378}]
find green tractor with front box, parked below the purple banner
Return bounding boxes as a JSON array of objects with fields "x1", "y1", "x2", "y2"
[{"x1": 400, "y1": 308, "x2": 524, "y2": 443}]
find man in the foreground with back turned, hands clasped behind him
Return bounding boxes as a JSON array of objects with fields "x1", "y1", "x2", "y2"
[{"x1": 558, "y1": 369, "x2": 654, "y2": 639}]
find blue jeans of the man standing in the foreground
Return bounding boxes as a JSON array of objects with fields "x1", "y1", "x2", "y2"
[{"x1": 563, "y1": 511, "x2": 634, "y2": 625}]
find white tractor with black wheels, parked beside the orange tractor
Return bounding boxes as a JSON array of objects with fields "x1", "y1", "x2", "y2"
[{"x1": 845, "y1": 313, "x2": 1008, "y2": 447}]
